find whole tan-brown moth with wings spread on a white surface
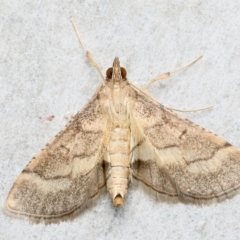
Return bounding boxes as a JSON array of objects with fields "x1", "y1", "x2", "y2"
[{"x1": 5, "y1": 20, "x2": 240, "y2": 222}]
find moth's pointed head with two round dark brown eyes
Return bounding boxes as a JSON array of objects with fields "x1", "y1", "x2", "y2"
[{"x1": 106, "y1": 57, "x2": 127, "y2": 82}]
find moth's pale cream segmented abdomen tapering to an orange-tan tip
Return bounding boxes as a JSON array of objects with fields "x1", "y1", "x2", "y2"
[{"x1": 105, "y1": 127, "x2": 130, "y2": 206}]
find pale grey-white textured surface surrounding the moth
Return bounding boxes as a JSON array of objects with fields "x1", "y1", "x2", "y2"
[{"x1": 0, "y1": 0, "x2": 240, "y2": 240}]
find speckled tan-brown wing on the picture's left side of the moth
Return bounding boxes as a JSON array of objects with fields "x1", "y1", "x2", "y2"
[{"x1": 5, "y1": 87, "x2": 105, "y2": 219}]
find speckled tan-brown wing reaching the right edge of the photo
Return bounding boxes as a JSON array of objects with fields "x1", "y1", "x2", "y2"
[{"x1": 132, "y1": 93, "x2": 240, "y2": 202}]
